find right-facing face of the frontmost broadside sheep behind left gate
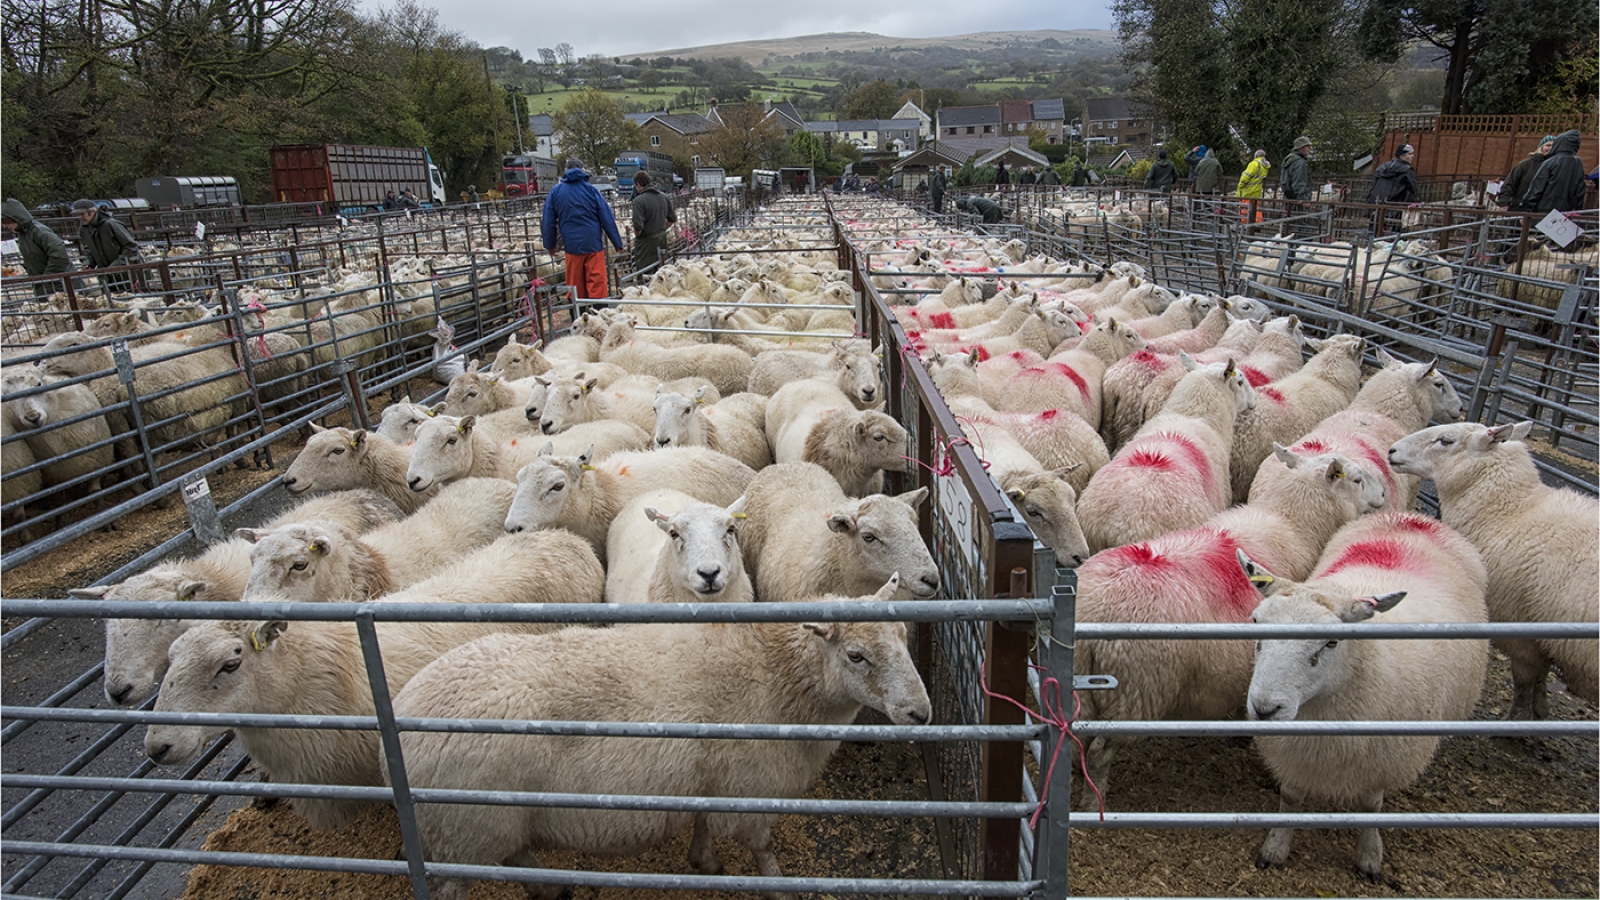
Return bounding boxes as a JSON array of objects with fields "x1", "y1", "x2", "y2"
[{"x1": 800, "y1": 575, "x2": 933, "y2": 725}]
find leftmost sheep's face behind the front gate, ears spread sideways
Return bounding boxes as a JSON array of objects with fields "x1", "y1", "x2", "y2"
[{"x1": 84, "y1": 565, "x2": 208, "y2": 706}]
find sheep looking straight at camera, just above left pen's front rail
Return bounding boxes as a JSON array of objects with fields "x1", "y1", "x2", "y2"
[{"x1": 605, "y1": 488, "x2": 755, "y2": 604}]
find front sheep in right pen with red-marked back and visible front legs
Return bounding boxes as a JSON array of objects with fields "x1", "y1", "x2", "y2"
[{"x1": 1240, "y1": 512, "x2": 1488, "y2": 882}]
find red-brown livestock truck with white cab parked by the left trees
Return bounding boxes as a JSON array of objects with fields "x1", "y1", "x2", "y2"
[{"x1": 270, "y1": 144, "x2": 445, "y2": 215}]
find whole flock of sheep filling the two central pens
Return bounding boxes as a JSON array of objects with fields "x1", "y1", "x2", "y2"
[{"x1": 18, "y1": 194, "x2": 1600, "y2": 900}]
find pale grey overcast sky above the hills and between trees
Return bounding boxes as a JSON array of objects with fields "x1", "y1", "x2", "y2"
[{"x1": 409, "y1": 0, "x2": 1112, "y2": 58}]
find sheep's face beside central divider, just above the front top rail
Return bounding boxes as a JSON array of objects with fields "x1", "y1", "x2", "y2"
[{"x1": 827, "y1": 487, "x2": 939, "y2": 599}]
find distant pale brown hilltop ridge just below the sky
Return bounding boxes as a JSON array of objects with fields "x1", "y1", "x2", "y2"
[{"x1": 621, "y1": 29, "x2": 1117, "y2": 67}]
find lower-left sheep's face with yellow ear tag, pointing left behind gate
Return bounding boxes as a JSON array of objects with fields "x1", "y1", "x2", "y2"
[{"x1": 144, "y1": 621, "x2": 288, "y2": 765}]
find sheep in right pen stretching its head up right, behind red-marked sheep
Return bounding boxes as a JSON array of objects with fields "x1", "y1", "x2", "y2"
[{"x1": 1227, "y1": 335, "x2": 1362, "y2": 498}]
